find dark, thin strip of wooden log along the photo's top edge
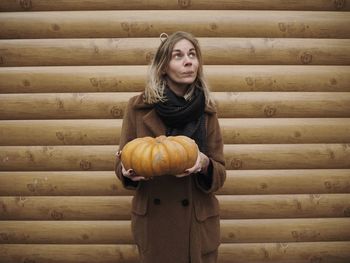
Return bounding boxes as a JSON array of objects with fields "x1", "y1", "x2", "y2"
[{"x1": 0, "y1": 0, "x2": 350, "y2": 12}]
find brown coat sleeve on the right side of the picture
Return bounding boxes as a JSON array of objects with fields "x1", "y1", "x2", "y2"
[{"x1": 195, "y1": 113, "x2": 226, "y2": 193}]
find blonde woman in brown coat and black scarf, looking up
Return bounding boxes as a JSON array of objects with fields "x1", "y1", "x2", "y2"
[{"x1": 116, "y1": 32, "x2": 226, "y2": 263}]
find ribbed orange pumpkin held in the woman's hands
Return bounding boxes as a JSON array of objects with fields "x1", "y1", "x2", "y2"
[{"x1": 121, "y1": 135, "x2": 198, "y2": 177}]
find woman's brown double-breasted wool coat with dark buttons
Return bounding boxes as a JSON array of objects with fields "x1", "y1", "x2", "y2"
[{"x1": 116, "y1": 94, "x2": 226, "y2": 263}]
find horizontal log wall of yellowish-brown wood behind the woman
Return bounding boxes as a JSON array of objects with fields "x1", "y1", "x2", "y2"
[{"x1": 0, "y1": 0, "x2": 350, "y2": 263}]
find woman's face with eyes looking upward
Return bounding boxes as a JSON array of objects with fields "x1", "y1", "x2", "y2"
[{"x1": 165, "y1": 39, "x2": 199, "y2": 95}]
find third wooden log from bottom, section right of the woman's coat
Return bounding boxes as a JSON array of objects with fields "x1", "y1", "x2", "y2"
[{"x1": 218, "y1": 194, "x2": 350, "y2": 219}]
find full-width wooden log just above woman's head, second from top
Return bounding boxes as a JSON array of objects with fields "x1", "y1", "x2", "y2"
[{"x1": 0, "y1": 10, "x2": 350, "y2": 39}]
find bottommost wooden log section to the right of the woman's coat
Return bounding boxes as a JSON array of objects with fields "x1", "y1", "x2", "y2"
[{"x1": 218, "y1": 242, "x2": 350, "y2": 263}]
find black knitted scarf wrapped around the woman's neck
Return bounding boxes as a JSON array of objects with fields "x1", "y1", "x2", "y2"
[{"x1": 155, "y1": 87, "x2": 206, "y2": 153}]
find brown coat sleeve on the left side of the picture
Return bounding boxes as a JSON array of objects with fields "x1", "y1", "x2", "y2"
[{"x1": 115, "y1": 98, "x2": 139, "y2": 190}]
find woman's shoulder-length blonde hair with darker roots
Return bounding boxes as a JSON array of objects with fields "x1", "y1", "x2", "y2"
[{"x1": 145, "y1": 31, "x2": 214, "y2": 104}]
